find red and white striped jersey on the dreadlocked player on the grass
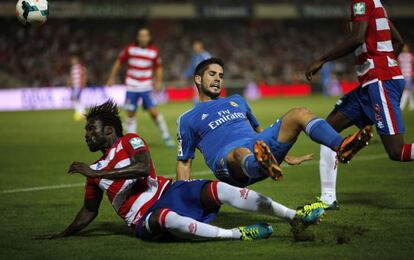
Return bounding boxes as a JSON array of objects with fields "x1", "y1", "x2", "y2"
[{"x1": 85, "y1": 134, "x2": 171, "y2": 226}]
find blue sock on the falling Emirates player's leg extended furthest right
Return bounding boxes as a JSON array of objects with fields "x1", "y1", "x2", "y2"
[{"x1": 305, "y1": 117, "x2": 344, "y2": 151}]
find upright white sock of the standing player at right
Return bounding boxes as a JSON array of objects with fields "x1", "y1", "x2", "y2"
[{"x1": 319, "y1": 145, "x2": 338, "y2": 204}]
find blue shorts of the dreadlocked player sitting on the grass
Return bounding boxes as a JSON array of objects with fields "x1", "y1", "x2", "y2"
[{"x1": 135, "y1": 180, "x2": 220, "y2": 240}]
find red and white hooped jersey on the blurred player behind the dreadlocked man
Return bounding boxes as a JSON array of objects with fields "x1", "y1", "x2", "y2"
[{"x1": 118, "y1": 44, "x2": 161, "y2": 92}]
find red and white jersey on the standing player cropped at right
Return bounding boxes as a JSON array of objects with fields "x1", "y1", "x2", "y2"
[{"x1": 351, "y1": 0, "x2": 403, "y2": 86}]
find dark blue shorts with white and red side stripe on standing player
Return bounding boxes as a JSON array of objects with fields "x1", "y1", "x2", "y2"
[{"x1": 336, "y1": 79, "x2": 404, "y2": 135}]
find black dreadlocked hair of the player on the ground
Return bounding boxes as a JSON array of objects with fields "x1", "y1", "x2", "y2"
[{"x1": 86, "y1": 99, "x2": 123, "y2": 137}]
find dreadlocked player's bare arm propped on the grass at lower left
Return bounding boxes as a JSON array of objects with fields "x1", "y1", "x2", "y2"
[{"x1": 33, "y1": 195, "x2": 102, "y2": 239}]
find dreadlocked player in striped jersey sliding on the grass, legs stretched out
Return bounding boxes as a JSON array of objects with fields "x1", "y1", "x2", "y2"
[{"x1": 37, "y1": 101, "x2": 324, "y2": 240}]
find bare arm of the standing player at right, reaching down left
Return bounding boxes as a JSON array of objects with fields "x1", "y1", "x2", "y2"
[{"x1": 305, "y1": 21, "x2": 368, "y2": 81}]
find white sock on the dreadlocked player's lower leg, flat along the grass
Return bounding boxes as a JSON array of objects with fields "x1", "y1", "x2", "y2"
[{"x1": 158, "y1": 209, "x2": 241, "y2": 239}]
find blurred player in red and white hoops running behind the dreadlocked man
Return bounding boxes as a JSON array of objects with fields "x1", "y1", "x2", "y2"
[{"x1": 106, "y1": 28, "x2": 174, "y2": 147}]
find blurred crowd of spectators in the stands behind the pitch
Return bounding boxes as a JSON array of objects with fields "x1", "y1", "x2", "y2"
[{"x1": 0, "y1": 19, "x2": 414, "y2": 88}]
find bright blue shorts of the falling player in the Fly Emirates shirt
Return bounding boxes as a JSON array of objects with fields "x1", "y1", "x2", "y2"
[{"x1": 213, "y1": 117, "x2": 293, "y2": 187}]
